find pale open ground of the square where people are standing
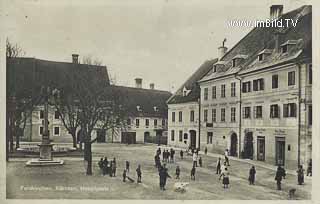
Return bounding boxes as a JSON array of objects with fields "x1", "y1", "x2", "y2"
[{"x1": 7, "y1": 144, "x2": 311, "y2": 200}]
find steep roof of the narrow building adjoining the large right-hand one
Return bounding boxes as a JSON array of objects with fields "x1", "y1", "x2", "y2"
[{"x1": 167, "y1": 59, "x2": 218, "y2": 104}]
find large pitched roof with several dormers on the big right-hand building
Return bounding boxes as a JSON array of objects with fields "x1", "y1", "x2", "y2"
[{"x1": 200, "y1": 6, "x2": 312, "y2": 82}]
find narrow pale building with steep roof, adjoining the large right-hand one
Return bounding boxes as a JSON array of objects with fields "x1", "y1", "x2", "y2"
[{"x1": 167, "y1": 59, "x2": 217, "y2": 148}]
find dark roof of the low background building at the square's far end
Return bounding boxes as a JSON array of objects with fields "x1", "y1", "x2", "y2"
[{"x1": 109, "y1": 85, "x2": 172, "y2": 118}]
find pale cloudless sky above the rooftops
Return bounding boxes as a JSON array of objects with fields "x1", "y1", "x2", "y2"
[{"x1": 3, "y1": 0, "x2": 308, "y2": 92}]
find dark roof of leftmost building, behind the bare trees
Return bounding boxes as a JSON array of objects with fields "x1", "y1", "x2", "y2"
[{"x1": 7, "y1": 58, "x2": 110, "y2": 101}]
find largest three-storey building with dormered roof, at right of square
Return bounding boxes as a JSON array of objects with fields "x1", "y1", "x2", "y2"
[{"x1": 199, "y1": 5, "x2": 312, "y2": 167}]
